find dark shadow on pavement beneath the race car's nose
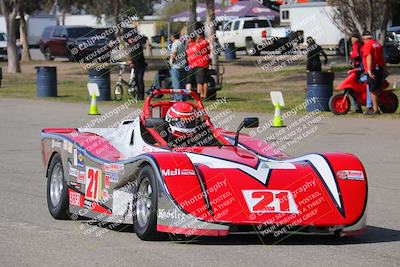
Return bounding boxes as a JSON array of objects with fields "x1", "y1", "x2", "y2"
[{"x1": 177, "y1": 226, "x2": 400, "y2": 245}]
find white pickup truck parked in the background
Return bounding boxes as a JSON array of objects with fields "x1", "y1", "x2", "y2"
[{"x1": 216, "y1": 17, "x2": 296, "y2": 56}]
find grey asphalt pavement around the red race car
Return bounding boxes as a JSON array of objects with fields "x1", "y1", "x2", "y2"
[{"x1": 0, "y1": 99, "x2": 400, "y2": 266}]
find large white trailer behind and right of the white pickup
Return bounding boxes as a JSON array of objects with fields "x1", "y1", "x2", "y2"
[{"x1": 280, "y1": 2, "x2": 345, "y2": 54}]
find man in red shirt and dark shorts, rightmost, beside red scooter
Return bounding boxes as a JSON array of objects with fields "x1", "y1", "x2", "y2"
[{"x1": 361, "y1": 31, "x2": 385, "y2": 115}]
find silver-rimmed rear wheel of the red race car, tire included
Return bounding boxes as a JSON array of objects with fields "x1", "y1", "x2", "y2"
[{"x1": 47, "y1": 154, "x2": 69, "y2": 220}]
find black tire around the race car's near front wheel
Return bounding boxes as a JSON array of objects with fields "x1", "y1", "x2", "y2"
[{"x1": 132, "y1": 165, "x2": 161, "y2": 241}]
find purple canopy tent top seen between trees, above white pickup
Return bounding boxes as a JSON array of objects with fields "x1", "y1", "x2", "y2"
[{"x1": 169, "y1": 1, "x2": 279, "y2": 22}]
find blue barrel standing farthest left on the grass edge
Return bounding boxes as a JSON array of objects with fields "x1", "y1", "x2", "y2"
[{"x1": 35, "y1": 66, "x2": 57, "y2": 97}]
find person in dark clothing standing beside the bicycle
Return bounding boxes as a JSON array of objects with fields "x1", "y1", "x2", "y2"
[{"x1": 128, "y1": 33, "x2": 147, "y2": 100}]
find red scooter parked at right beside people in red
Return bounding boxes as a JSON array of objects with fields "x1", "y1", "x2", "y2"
[{"x1": 329, "y1": 69, "x2": 399, "y2": 115}]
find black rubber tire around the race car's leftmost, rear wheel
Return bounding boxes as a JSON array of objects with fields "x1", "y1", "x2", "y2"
[{"x1": 47, "y1": 154, "x2": 70, "y2": 220}]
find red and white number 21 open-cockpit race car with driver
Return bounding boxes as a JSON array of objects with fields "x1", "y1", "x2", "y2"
[{"x1": 41, "y1": 89, "x2": 368, "y2": 240}]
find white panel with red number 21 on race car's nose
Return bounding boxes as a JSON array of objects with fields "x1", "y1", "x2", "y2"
[{"x1": 242, "y1": 190, "x2": 298, "y2": 213}]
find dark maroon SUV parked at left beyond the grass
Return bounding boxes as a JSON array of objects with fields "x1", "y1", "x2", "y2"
[{"x1": 39, "y1": 26, "x2": 107, "y2": 61}]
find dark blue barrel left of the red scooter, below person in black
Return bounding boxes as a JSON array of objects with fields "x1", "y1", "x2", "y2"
[{"x1": 306, "y1": 71, "x2": 335, "y2": 112}]
